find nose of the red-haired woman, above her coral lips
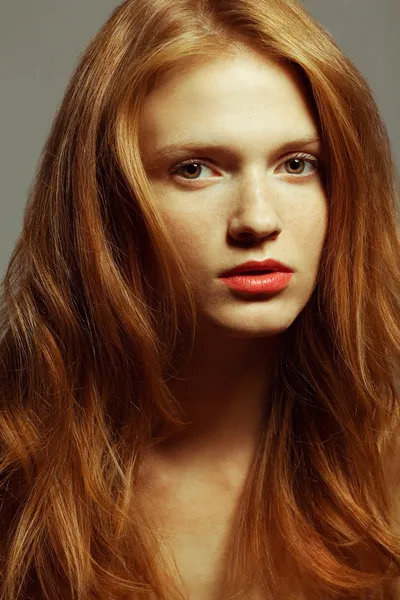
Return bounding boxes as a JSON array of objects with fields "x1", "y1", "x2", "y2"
[{"x1": 228, "y1": 175, "x2": 283, "y2": 241}]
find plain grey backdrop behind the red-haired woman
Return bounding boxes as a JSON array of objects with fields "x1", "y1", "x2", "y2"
[{"x1": 0, "y1": 0, "x2": 400, "y2": 279}]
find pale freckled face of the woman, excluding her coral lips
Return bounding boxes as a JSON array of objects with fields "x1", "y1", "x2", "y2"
[{"x1": 140, "y1": 51, "x2": 327, "y2": 337}]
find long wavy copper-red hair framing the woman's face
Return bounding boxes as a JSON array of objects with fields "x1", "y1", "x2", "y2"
[{"x1": 0, "y1": 0, "x2": 400, "y2": 600}]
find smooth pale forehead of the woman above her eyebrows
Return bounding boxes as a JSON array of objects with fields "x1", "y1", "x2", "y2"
[{"x1": 140, "y1": 51, "x2": 318, "y2": 158}]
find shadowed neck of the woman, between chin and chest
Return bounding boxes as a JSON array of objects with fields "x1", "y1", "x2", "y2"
[{"x1": 156, "y1": 328, "x2": 283, "y2": 466}]
